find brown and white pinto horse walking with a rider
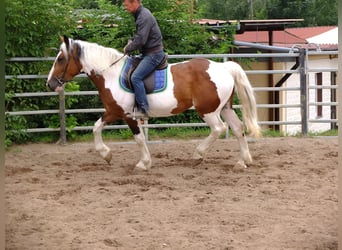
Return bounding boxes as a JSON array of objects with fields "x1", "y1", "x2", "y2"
[{"x1": 46, "y1": 36, "x2": 261, "y2": 170}]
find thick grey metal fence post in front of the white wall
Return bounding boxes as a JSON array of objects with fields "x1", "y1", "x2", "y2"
[{"x1": 299, "y1": 48, "x2": 308, "y2": 136}]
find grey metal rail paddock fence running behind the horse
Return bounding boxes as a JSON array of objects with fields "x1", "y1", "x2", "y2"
[{"x1": 5, "y1": 48, "x2": 338, "y2": 144}]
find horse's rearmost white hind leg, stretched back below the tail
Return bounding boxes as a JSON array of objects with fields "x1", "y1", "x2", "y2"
[{"x1": 221, "y1": 105, "x2": 252, "y2": 167}]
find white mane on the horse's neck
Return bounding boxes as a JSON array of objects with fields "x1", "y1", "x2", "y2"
[{"x1": 74, "y1": 40, "x2": 123, "y2": 74}]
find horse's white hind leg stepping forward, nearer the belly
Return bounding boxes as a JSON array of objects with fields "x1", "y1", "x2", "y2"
[{"x1": 193, "y1": 114, "x2": 227, "y2": 160}]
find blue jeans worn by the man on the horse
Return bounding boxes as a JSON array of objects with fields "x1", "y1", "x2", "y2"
[{"x1": 131, "y1": 51, "x2": 164, "y2": 112}]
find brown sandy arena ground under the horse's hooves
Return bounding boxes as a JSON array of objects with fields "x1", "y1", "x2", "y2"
[{"x1": 5, "y1": 138, "x2": 338, "y2": 250}]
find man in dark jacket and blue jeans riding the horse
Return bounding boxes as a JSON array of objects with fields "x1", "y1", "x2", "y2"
[{"x1": 122, "y1": 0, "x2": 164, "y2": 114}]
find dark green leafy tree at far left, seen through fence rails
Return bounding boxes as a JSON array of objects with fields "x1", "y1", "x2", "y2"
[{"x1": 5, "y1": 0, "x2": 76, "y2": 144}]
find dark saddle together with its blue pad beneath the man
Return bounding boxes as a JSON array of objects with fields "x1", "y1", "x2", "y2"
[{"x1": 120, "y1": 54, "x2": 168, "y2": 94}]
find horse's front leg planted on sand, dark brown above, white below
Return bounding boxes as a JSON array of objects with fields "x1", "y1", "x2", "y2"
[{"x1": 126, "y1": 119, "x2": 152, "y2": 170}]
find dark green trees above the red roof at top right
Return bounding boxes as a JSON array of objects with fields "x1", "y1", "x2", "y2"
[{"x1": 196, "y1": 0, "x2": 338, "y2": 26}]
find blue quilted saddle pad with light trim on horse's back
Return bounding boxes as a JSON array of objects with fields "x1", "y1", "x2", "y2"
[{"x1": 119, "y1": 57, "x2": 167, "y2": 93}]
